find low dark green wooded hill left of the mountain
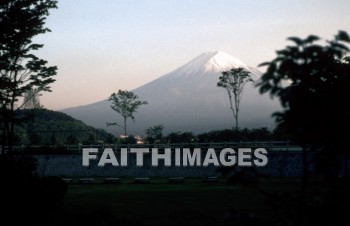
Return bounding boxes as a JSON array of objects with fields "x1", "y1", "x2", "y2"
[{"x1": 15, "y1": 109, "x2": 112, "y2": 145}]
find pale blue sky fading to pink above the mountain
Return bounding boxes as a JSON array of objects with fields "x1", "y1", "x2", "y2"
[{"x1": 35, "y1": 0, "x2": 350, "y2": 110}]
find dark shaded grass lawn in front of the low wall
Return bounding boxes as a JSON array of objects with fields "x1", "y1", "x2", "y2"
[{"x1": 58, "y1": 179, "x2": 299, "y2": 226}]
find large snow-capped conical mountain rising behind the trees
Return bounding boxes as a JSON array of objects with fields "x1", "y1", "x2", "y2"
[{"x1": 62, "y1": 51, "x2": 280, "y2": 135}]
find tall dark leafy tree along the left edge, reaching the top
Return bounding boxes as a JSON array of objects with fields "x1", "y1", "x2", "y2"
[{"x1": 0, "y1": 0, "x2": 57, "y2": 151}]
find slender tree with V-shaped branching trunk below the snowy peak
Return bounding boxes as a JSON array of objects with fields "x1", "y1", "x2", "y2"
[{"x1": 217, "y1": 68, "x2": 253, "y2": 131}]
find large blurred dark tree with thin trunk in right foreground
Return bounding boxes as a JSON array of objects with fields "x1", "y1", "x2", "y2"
[{"x1": 258, "y1": 31, "x2": 350, "y2": 225}]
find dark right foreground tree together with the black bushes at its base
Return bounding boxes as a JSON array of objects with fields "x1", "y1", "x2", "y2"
[{"x1": 254, "y1": 31, "x2": 350, "y2": 226}]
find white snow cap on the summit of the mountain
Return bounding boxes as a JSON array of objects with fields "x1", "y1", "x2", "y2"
[{"x1": 165, "y1": 51, "x2": 256, "y2": 78}]
